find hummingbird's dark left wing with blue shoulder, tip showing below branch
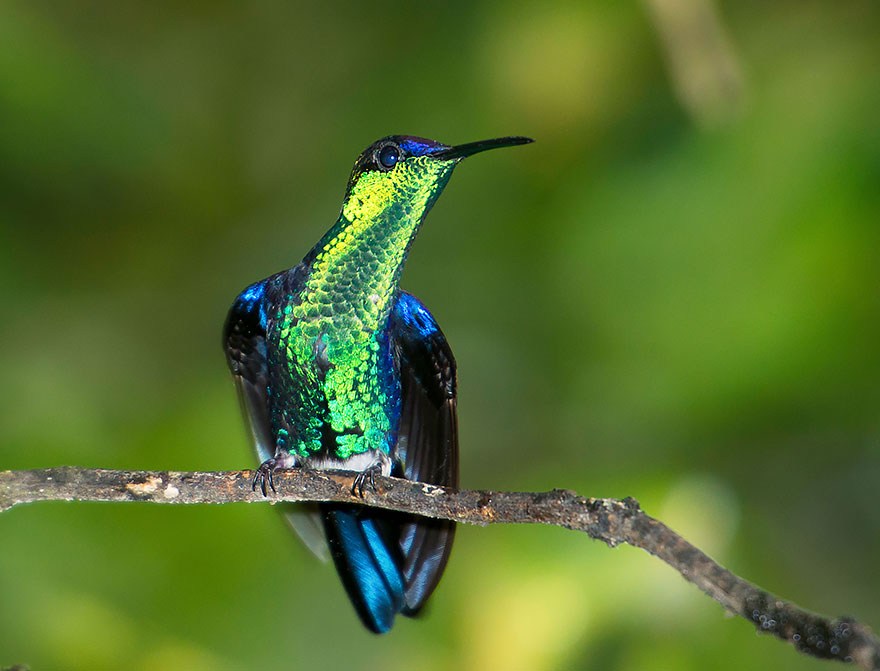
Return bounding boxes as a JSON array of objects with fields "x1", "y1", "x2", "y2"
[{"x1": 223, "y1": 280, "x2": 329, "y2": 561}]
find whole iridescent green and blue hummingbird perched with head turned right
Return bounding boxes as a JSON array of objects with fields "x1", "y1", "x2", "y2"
[{"x1": 223, "y1": 135, "x2": 532, "y2": 633}]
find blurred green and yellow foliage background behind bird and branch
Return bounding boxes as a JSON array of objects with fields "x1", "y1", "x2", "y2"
[{"x1": 0, "y1": 0, "x2": 880, "y2": 671}]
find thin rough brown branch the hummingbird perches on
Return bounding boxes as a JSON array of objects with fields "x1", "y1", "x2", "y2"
[{"x1": 0, "y1": 466, "x2": 880, "y2": 671}]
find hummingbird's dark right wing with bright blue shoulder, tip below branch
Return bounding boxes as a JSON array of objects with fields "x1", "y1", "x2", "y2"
[{"x1": 390, "y1": 291, "x2": 458, "y2": 615}]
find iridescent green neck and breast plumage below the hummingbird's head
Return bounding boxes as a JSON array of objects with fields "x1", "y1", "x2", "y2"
[{"x1": 276, "y1": 178, "x2": 430, "y2": 460}]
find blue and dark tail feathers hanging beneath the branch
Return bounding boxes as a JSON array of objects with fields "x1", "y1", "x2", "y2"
[{"x1": 320, "y1": 504, "x2": 454, "y2": 634}]
